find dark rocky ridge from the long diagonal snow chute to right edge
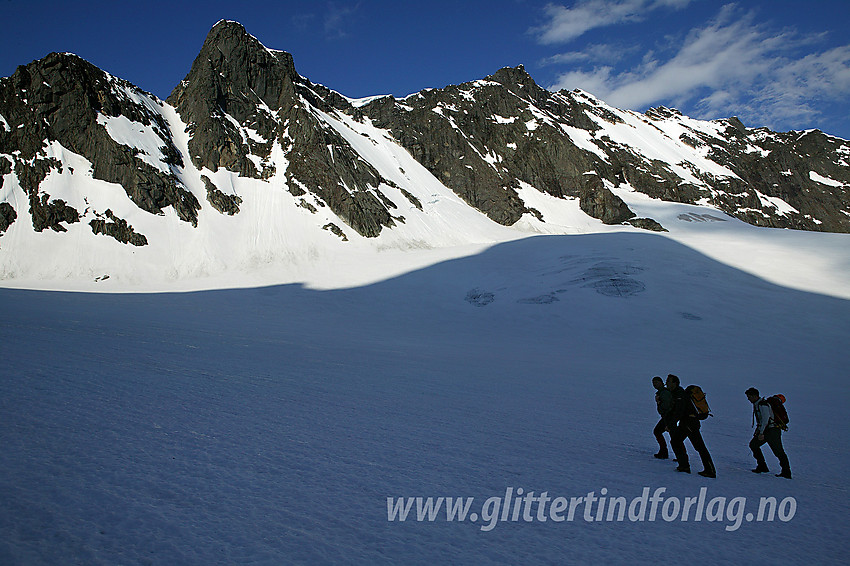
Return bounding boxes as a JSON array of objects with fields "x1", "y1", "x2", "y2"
[{"x1": 359, "y1": 70, "x2": 850, "y2": 232}]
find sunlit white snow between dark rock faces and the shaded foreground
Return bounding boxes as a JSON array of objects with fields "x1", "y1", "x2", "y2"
[{"x1": 0, "y1": 95, "x2": 850, "y2": 304}]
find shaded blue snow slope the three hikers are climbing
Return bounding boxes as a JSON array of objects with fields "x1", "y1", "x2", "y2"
[{"x1": 0, "y1": 225, "x2": 850, "y2": 565}]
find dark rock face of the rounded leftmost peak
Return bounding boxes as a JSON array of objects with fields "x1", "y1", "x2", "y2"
[{"x1": 0, "y1": 53, "x2": 200, "y2": 224}]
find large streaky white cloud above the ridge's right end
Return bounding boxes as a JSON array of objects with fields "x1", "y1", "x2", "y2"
[{"x1": 536, "y1": 0, "x2": 850, "y2": 130}]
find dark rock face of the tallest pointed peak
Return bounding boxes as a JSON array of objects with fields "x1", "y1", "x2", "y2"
[{"x1": 168, "y1": 21, "x2": 394, "y2": 237}]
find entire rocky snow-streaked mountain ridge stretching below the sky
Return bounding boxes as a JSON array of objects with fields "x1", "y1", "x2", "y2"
[{"x1": 0, "y1": 20, "x2": 850, "y2": 288}]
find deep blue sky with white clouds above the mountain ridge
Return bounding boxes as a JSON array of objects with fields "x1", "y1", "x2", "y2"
[{"x1": 0, "y1": 0, "x2": 850, "y2": 138}]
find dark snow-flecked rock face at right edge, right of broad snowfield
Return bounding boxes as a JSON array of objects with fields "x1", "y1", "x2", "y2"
[{"x1": 623, "y1": 107, "x2": 850, "y2": 232}]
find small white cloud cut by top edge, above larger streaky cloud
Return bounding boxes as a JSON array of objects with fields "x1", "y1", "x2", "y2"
[{"x1": 531, "y1": 0, "x2": 691, "y2": 44}]
